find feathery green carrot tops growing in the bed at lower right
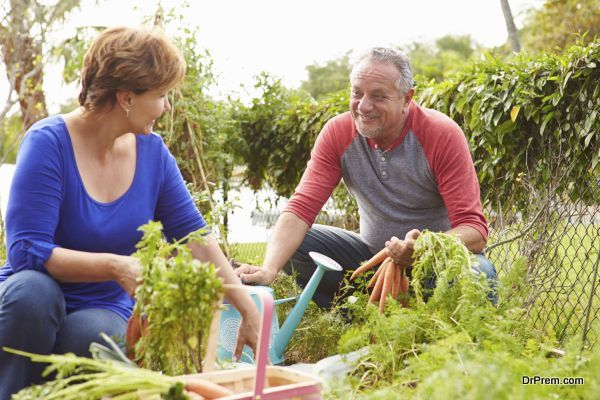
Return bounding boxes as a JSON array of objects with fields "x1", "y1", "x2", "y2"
[{"x1": 332, "y1": 232, "x2": 600, "y2": 399}]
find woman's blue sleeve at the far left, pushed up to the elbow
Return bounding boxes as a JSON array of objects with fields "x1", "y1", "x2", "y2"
[{"x1": 6, "y1": 128, "x2": 63, "y2": 272}]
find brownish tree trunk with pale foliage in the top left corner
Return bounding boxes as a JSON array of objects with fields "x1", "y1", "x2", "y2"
[{"x1": 0, "y1": 0, "x2": 79, "y2": 128}]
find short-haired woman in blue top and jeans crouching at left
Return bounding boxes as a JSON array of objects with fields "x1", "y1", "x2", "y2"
[{"x1": 0, "y1": 27, "x2": 258, "y2": 400}]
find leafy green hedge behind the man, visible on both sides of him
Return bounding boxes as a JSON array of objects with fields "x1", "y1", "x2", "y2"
[{"x1": 237, "y1": 41, "x2": 600, "y2": 212}]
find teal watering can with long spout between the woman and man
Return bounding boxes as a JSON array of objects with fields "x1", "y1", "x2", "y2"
[{"x1": 217, "y1": 251, "x2": 342, "y2": 364}]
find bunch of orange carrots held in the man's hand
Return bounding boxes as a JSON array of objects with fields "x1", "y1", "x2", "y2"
[{"x1": 350, "y1": 248, "x2": 408, "y2": 313}]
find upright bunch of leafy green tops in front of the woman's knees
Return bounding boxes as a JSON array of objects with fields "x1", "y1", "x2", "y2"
[{"x1": 134, "y1": 222, "x2": 223, "y2": 375}]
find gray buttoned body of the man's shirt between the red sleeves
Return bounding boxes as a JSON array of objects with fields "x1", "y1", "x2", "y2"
[{"x1": 341, "y1": 130, "x2": 450, "y2": 252}]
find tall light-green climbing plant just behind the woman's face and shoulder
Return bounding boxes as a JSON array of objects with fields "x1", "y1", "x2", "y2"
[{"x1": 156, "y1": 21, "x2": 242, "y2": 247}]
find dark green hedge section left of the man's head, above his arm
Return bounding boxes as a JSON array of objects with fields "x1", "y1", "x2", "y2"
[{"x1": 235, "y1": 74, "x2": 347, "y2": 196}]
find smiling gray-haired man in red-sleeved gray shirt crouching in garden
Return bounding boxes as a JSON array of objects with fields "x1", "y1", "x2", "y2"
[{"x1": 236, "y1": 48, "x2": 496, "y2": 307}]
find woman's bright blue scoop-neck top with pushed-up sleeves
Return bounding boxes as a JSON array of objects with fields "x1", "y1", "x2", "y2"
[{"x1": 0, "y1": 116, "x2": 206, "y2": 319}]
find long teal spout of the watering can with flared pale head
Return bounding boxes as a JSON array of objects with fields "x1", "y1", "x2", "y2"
[{"x1": 271, "y1": 251, "x2": 342, "y2": 360}]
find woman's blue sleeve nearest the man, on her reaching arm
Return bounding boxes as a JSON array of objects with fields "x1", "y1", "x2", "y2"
[{"x1": 156, "y1": 143, "x2": 206, "y2": 241}]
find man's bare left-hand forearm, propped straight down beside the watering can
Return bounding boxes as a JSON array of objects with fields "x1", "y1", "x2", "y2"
[{"x1": 263, "y1": 212, "x2": 310, "y2": 274}]
